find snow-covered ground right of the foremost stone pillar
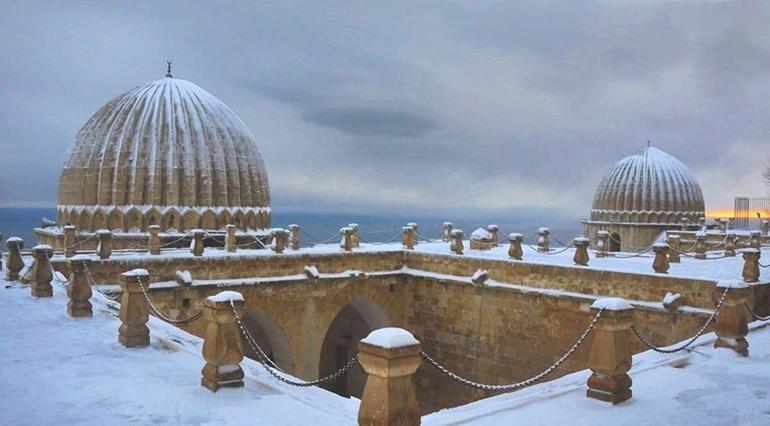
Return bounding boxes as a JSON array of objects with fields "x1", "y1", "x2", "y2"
[{"x1": 422, "y1": 323, "x2": 770, "y2": 426}]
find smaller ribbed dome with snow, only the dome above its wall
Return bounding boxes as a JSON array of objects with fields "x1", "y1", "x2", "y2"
[{"x1": 591, "y1": 147, "x2": 705, "y2": 223}]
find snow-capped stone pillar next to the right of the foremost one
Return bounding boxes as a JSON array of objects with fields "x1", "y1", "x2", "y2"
[{"x1": 586, "y1": 297, "x2": 634, "y2": 405}]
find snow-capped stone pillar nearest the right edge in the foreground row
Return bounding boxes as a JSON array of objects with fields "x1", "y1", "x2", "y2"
[{"x1": 714, "y1": 280, "x2": 749, "y2": 356}]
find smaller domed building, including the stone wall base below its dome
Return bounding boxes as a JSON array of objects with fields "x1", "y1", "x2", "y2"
[{"x1": 583, "y1": 146, "x2": 705, "y2": 251}]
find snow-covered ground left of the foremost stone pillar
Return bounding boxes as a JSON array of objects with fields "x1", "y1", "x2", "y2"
[{"x1": 0, "y1": 280, "x2": 358, "y2": 425}]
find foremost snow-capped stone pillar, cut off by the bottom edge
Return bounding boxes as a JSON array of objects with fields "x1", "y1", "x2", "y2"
[{"x1": 358, "y1": 327, "x2": 422, "y2": 426}]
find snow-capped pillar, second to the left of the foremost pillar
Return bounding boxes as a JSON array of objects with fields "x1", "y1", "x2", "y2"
[{"x1": 118, "y1": 269, "x2": 150, "y2": 348}]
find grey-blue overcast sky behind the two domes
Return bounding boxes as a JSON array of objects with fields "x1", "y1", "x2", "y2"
[{"x1": 0, "y1": 0, "x2": 770, "y2": 216}]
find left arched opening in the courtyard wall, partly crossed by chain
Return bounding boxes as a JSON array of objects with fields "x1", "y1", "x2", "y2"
[{"x1": 241, "y1": 309, "x2": 294, "y2": 374}]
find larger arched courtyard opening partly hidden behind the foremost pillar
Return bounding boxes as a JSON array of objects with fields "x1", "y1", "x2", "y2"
[{"x1": 318, "y1": 299, "x2": 390, "y2": 398}]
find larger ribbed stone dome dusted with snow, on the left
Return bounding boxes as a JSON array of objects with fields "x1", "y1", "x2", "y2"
[{"x1": 59, "y1": 74, "x2": 270, "y2": 231}]
